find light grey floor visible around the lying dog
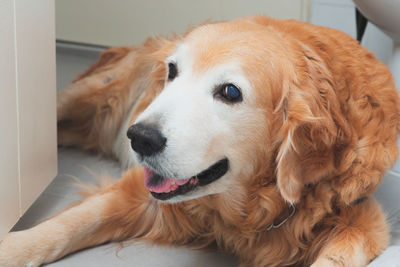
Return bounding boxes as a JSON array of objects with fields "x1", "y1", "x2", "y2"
[{"x1": 13, "y1": 43, "x2": 400, "y2": 267}]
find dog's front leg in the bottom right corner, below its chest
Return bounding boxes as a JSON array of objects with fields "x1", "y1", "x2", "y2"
[{"x1": 311, "y1": 197, "x2": 389, "y2": 267}]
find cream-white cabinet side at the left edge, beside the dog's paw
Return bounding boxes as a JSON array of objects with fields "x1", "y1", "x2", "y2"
[{"x1": 0, "y1": 0, "x2": 57, "y2": 239}]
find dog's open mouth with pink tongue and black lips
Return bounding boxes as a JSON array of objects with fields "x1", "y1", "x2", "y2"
[{"x1": 144, "y1": 158, "x2": 229, "y2": 200}]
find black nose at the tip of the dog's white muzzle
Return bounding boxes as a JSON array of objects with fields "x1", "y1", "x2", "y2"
[{"x1": 127, "y1": 123, "x2": 167, "y2": 156}]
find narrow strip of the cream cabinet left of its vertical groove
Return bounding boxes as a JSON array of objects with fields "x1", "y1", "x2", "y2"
[{"x1": 0, "y1": 0, "x2": 19, "y2": 239}]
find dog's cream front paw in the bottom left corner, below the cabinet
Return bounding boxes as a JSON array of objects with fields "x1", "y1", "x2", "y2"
[{"x1": 0, "y1": 231, "x2": 42, "y2": 267}]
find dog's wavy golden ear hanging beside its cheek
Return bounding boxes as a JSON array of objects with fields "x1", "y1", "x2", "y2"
[{"x1": 275, "y1": 48, "x2": 346, "y2": 203}]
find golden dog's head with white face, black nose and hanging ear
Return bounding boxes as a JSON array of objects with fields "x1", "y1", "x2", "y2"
[{"x1": 128, "y1": 19, "x2": 345, "y2": 202}]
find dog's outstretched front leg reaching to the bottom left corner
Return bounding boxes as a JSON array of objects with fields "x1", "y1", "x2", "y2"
[{"x1": 0, "y1": 169, "x2": 195, "y2": 266}]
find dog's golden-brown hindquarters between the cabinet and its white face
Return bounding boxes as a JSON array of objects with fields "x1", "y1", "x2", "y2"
[{"x1": 57, "y1": 37, "x2": 175, "y2": 154}]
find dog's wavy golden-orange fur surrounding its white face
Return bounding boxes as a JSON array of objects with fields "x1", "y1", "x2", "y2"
[{"x1": 0, "y1": 17, "x2": 399, "y2": 266}]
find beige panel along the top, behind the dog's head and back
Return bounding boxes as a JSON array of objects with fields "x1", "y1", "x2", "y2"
[{"x1": 56, "y1": 0, "x2": 309, "y2": 46}]
